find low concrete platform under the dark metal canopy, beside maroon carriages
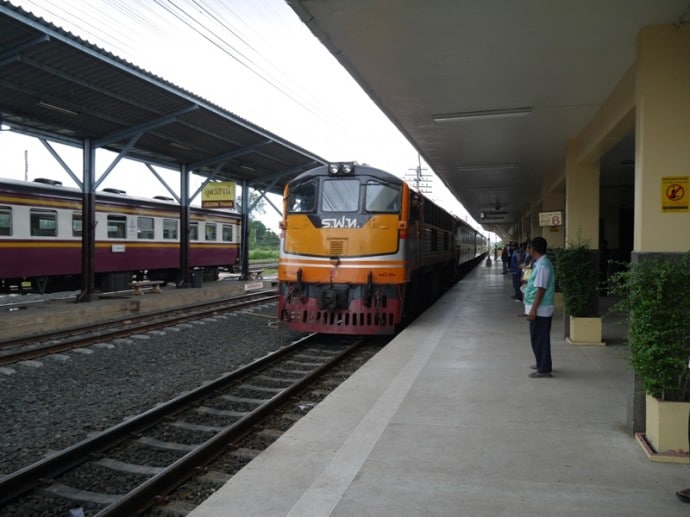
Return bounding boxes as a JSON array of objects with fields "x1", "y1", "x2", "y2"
[{"x1": 0, "y1": 277, "x2": 277, "y2": 342}]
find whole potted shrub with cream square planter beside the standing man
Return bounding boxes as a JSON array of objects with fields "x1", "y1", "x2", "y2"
[{"x1": 554, "y1": 240, "x2": 603, "y2": 345}]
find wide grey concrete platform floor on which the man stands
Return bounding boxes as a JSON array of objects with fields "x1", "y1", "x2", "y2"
[{"x1": 189, "y1": 264, "x2": 690, "y2": 517}]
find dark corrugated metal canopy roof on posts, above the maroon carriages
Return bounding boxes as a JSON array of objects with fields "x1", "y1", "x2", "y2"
[{"x1": 0, "y1": 0, "x2": 325, "y2": 197}]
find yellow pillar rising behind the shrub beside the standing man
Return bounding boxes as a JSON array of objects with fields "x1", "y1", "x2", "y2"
[{"x1": 565, "y1": 140, "x2": 599, "y2": 249}]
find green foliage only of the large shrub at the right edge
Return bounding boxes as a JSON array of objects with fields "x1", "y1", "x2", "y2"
[{"x1": 610, "y1": 252, "x2": 690, "y2": 402}]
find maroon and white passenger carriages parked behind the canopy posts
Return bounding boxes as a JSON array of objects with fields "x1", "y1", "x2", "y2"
[{"x1": 0, "y1": 178, "x2": 242, "y2": 293}]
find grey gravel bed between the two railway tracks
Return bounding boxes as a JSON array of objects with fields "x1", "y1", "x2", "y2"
[{"x1": 0, "y1": 304, "x2": 303, "y2": 476}]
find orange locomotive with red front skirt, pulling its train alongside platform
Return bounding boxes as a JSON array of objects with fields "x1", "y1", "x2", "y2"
[{"x1": 278, "y1": 162, "x2": 488, "y2": 335}]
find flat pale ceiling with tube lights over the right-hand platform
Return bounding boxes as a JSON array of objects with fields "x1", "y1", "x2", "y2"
[{"x1": 288, "y1": 0, "x2": 690, "y2": 237}]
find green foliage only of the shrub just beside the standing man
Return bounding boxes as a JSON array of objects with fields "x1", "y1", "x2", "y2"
[{"x1": 549, "y1": 242, "x2": 599, "y2": 318}]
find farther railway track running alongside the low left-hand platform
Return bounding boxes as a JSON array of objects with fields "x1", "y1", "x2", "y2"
[{"x1": 0, "y1": 290, "x2": 277, "y2": 366}]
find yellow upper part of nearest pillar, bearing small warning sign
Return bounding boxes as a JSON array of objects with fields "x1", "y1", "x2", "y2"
[{"x1": 634, "y1": 25, "x2": 690, "y2": 252}]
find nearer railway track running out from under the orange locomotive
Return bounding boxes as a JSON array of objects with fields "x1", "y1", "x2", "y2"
[{"x1": 0, "y1": 335, "x2": 388, "y2": 516}]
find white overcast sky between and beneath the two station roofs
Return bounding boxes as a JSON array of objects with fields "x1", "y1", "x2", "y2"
[{"x1": 0, "y1": 0, "x2": 480, "y2": 231}]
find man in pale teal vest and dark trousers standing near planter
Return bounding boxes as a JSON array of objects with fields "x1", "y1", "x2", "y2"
[{"x1": 524, "y1": 237, "x2": 556, "y2": 378}]
